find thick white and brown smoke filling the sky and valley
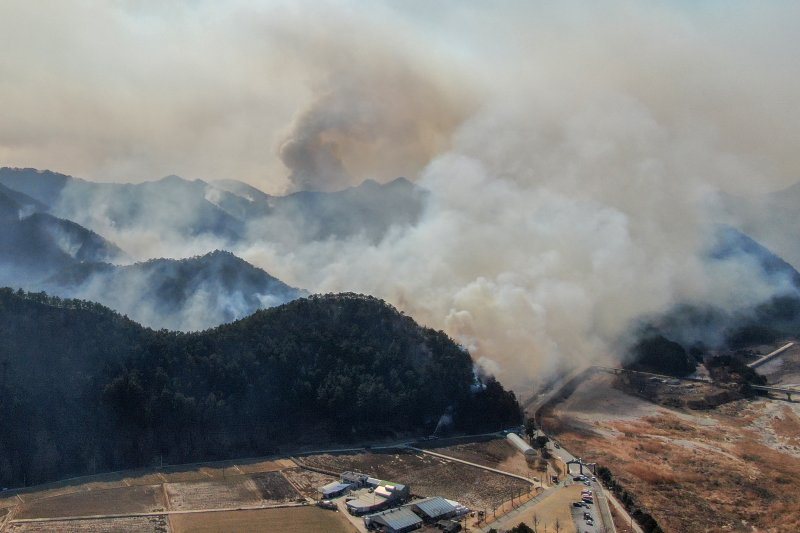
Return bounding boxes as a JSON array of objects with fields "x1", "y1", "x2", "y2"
[{"x1": 0, "y1": 1, "x2": 800, "y2": 385}]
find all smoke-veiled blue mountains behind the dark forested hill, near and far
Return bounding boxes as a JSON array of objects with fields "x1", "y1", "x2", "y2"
[{"x1": 0, "y1": 168, "x2": 425, "y2": 330}]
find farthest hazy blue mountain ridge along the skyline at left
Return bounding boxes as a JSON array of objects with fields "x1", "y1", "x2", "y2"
[{"x1": 0, "y1": 168, "x2": 426, "y2": 246}]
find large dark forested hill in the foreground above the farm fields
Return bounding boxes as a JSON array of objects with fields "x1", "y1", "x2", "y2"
[{"x1": 0, "y1": 289, "x2": 519, "y2": 486}]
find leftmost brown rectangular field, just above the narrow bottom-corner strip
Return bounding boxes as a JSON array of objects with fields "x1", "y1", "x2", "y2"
[{"x1": 15, "y1": 485, "x2": 164, "y2": 518}]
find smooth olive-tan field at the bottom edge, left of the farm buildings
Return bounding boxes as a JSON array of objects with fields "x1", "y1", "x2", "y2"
[{"x1": 170, "y1": 507, "x2": 357, "y2": 533}]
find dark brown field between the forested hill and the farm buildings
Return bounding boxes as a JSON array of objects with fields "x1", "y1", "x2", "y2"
[{"x1": 303, "y1": 450, "x2": 531, "y2": 509}]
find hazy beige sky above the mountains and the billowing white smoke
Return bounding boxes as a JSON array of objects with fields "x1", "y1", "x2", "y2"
[{"x1": 0, "y1": 0, "x2": 800, "y2": 192}]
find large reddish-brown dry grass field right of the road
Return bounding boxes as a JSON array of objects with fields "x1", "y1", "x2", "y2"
[{"x1": 543, "y1": 370, "x2": 800, "y2": 533}]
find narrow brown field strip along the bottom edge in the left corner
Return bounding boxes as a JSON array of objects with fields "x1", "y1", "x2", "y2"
[{"x1": 6, "y1": 515, "x2": 169, "y2": 533}]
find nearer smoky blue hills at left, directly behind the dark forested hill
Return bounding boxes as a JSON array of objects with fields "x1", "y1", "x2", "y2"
[{"x1": 0, "y1": 178, "x2": 305, "y2": 330}]
